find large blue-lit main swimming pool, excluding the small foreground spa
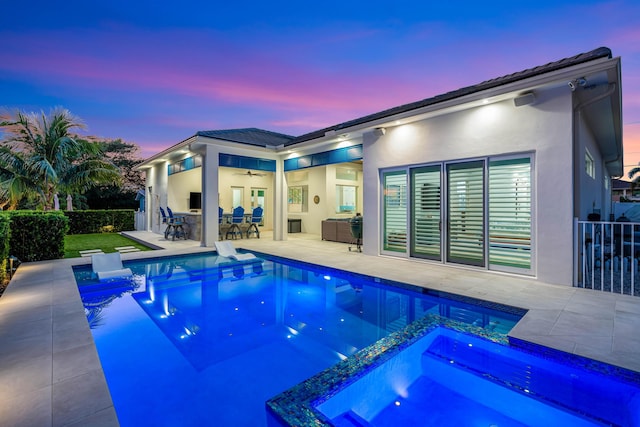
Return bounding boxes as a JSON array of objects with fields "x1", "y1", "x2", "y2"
[{"x1": 74, "y1": 253, "x2": 524, "y2": 426}]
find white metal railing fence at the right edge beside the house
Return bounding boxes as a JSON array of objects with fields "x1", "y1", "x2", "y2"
[{"x1": 574, "y1": 220, "x2": 640, "y2": 296}]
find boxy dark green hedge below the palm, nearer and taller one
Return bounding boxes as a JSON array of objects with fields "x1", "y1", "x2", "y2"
[{"x1": 9, "y1": 211, "x2": 69, "y2": 262}]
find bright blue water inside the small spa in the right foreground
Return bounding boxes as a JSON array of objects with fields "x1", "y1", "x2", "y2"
[{"x1": 316, "y1": 327, "x2": 640, "y2": 427}]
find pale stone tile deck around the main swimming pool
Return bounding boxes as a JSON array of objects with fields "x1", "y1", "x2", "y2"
[{"x1": 0, "y1": 232, "x2": 640, "y2": 426}]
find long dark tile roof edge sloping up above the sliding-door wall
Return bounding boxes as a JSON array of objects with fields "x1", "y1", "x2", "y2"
[{"x1": 285, "y1": 47, "x2": 612, "y2": 145}]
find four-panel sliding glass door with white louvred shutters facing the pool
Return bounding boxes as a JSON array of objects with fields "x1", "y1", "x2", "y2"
[{"x1": 382, "y1": 154, "x2": 534, "y2": 274}]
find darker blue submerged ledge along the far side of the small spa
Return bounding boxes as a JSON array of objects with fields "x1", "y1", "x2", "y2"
[{"x1": 423, "y1": 335, "x2": 640, "y2": 425}]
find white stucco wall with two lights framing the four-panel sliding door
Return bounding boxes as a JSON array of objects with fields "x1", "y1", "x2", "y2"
[{"x1": 364, "y1": 87, "x2": 574, "y2": 285}]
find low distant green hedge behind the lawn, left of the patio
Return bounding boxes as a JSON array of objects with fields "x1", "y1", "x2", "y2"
[{"x1": 64, "y1": 209, "x2": 135, "y2": 234}]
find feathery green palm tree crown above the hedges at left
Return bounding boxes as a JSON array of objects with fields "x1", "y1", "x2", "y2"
[{"x1": 0, "y1": 107, "x2": 120, "y2": 210}]
